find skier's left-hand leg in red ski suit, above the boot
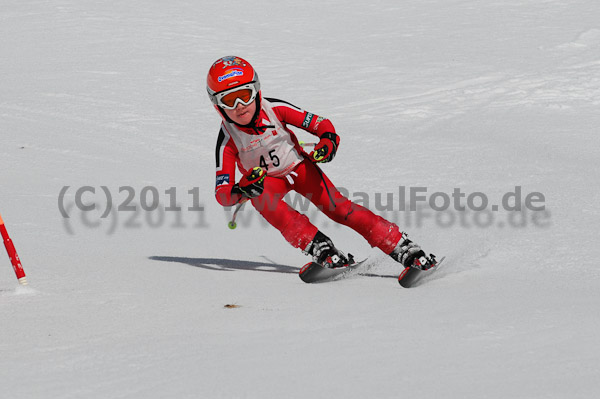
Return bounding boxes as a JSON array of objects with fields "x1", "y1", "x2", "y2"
[{"x1": 252, "y1": 176, "x2": 318, "y2": 250}]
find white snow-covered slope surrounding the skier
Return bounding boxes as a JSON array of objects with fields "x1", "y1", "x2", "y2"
[{"x1": 0, "y1": 0, "x2": 600, "y2": 398}]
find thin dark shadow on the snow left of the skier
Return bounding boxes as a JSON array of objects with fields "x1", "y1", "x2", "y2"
[{"x1": 149, "y1": 256, "x2": 300, "y2": 274}]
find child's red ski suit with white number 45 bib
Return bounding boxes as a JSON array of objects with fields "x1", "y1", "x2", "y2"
[{"x1": 215, "y1": 98, "x2": 402, "y2": 254}]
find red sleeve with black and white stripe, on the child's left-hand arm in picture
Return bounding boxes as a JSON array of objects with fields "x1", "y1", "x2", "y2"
[{"x1": 215, "y1": 128, "x2": 242, "y2": 206}]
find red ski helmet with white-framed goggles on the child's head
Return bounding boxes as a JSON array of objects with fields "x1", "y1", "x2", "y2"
[{"x1": 206, "y1": 56, "x2": 260, "y2": 109}]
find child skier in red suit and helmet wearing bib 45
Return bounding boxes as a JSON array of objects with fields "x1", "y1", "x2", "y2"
[{"x1": 206, "y1": 56, "x2": 435, "y2": 270}]
